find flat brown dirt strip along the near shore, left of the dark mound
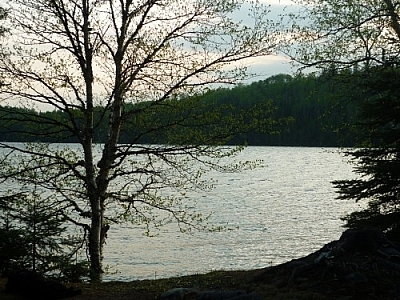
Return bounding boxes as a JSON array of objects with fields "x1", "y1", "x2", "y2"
[{"x1": 0, "y1": 269, "x2": 334, "y2": 300}]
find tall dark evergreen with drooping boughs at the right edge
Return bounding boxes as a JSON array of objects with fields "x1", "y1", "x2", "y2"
[{"x1": 334, "y1": 66, "x2": 400, "y2": 240}]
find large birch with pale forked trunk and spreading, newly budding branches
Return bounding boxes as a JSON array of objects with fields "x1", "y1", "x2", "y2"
[{"x1": 0, "y1": 0, "x2": 280, "y2": 281}]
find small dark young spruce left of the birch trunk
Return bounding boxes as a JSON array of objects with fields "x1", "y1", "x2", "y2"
[{"x1": 0, "y1": 191, "x2": 87, "y2": 281}]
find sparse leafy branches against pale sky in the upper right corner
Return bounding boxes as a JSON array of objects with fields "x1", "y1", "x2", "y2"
[{"x1": 287, "y1": 0, "x2": 400, "y2": 69}]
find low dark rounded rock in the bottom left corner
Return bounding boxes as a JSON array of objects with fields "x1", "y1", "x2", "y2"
[{"x1": 6, "y1": 271, "x2": 81, "y2": 300}]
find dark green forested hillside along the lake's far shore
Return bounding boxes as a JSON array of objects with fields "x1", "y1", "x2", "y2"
[{"x1": 0, "y1": 73, "x2": 356, "y2": 146}]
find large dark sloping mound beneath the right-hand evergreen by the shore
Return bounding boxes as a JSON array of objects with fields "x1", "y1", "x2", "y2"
[{"x1": 253, "y1": 228, "x2": 400, "y2": 300}]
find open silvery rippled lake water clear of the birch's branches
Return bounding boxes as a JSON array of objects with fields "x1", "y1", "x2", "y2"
[{"x1": 104, "y1": 147, "x2": 358, "y2": 281}]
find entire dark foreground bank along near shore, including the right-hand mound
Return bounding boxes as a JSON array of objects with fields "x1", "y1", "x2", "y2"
[{"x1": 0, "y1": 229, "x2": 400, "y2": 300}]
